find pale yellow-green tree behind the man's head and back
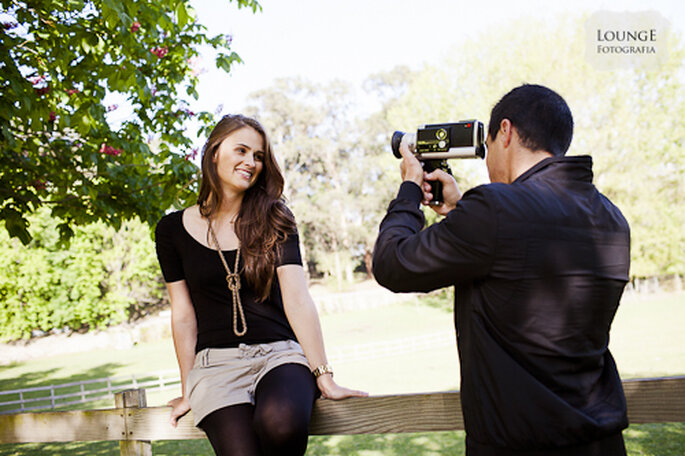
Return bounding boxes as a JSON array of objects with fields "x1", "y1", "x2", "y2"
[{"x1": 387, "y1": 17, "x2": 685, "y2": 277}]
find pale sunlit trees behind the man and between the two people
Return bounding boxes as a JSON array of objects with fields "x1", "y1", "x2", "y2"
[{"x1": 250, "y1": 17, "x2": 685, "y2": 278}]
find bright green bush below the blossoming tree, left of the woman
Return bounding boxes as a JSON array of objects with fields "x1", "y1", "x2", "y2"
[{"x1": 0, "y1": 210, "x2": 163, "y2": 341}]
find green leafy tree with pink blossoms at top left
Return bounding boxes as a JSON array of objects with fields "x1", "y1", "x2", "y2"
[{"x1": 0, "y1": 0, "x2": 261, "y2": 244}]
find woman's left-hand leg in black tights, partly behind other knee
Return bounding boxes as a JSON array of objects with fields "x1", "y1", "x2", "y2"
[{"x1": 198, "y1": 404, "x2": 261, "y2": 456}]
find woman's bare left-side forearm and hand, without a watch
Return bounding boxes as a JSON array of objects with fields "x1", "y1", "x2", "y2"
[{"x1": 166, "y1": 280, "x2": 197, "y2": 427}]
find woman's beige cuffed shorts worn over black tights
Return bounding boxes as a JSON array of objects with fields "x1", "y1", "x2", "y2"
[{"x1": 186, "y1": 340, "x2": 309, "y2": 426}]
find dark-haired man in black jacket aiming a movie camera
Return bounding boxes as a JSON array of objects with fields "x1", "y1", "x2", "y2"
[{"x1": 373, "y1": 85, "x2": 630, "y2": 456}]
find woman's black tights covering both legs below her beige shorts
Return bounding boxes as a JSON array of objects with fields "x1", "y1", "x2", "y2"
[{"x1": 199, "y1": 364, "x2": 317, "y2": 456}]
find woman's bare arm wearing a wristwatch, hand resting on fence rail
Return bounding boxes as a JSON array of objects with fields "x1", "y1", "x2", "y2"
[{"x1": 276, "y1": 264, "x2": 367, "y2": 399}]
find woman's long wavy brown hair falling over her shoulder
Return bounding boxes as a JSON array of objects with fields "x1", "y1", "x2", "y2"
[{"x1": 197, "y1": 114, "x2": 295, "y2": 301}]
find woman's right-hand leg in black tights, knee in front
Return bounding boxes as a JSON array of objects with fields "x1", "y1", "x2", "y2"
[{"x1": 254, "y1": 364, "x2": 317, "y2": 456}]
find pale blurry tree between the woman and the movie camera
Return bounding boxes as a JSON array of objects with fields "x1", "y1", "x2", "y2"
[{"x1": 247, "y1": 79, "x2": 394, "y2": 289}]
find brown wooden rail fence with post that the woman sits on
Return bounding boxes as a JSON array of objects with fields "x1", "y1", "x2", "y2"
[{"x1": 0, "y1": 377, "x2": 685, "y2": 456}]
